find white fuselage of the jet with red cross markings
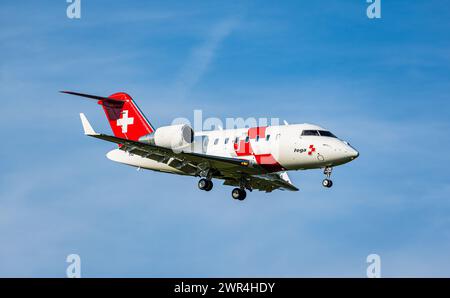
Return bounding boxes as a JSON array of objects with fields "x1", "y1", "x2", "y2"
[{"x1": 107, "y1": 124, "x2": 359, "y2": 174}]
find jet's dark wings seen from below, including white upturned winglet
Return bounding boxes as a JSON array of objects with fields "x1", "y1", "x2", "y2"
[{"x1": 80, "y1": 113, "x2": 298, "y2": 192}]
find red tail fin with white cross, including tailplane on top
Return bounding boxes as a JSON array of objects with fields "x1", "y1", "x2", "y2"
[{"x1": 61, "y1": 91, "x2": 154, "y2": 141}]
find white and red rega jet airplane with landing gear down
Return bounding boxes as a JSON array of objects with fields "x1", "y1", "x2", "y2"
[{"x1": 60, "y1": 91, "x2": 359, "y2": 201}]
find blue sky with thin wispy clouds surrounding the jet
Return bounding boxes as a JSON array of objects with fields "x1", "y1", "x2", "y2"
[{"x1": 0, "y1": 0, "x2": 450, "y2": 277}]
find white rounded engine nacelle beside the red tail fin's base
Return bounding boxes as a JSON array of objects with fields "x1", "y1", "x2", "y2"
[{"x1": 139, "y1": 124, "x2": 194, "y2": 149}]
